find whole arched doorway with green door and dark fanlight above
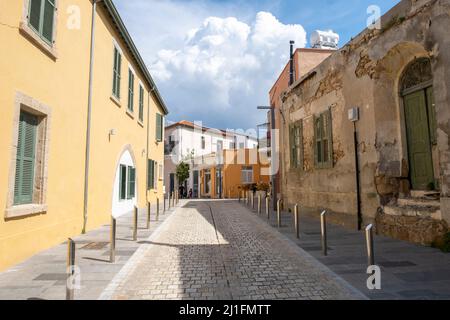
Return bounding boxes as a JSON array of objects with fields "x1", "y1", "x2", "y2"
[{"x1": 400, "y1": 58, "x2": 437, "y2": 190}]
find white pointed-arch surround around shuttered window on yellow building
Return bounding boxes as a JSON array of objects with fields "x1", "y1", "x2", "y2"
[{"x1": 111, "y1": 144, "x2": 139, "y2": 217}]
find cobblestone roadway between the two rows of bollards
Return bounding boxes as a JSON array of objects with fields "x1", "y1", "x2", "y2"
[{"x1": 106, "y1": 201, "x2": 365, "y2": 300}]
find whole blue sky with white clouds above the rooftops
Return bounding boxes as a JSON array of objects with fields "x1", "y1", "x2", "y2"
[{"x1": 114, "y1": 0, "x2": 399, "y2": 130}]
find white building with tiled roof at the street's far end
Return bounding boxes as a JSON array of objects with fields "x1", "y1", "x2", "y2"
[{"x1": 164, "y1": 120, "x2": 258, "y2": 197}]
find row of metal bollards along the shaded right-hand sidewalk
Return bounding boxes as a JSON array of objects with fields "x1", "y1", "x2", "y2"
[{"x1": 239, "y1": 195, "x2": 375, "y2": 266}]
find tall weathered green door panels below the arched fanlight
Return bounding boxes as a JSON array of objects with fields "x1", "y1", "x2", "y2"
[{"x1": 404, "y1": 90, "x2": 434, "y2": 190}]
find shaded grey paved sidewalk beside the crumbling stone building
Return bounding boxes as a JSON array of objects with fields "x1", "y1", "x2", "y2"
[{"x1": 241, "y1": 200, "x2": 450, "y2": 300}]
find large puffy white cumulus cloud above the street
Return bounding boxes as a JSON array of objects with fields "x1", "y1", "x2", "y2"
[{"x1": 150, "y1": 12, "x2": 306, "y2": 128}]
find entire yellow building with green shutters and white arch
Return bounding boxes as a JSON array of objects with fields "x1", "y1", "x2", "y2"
[{"x1": 0, "y1": 0, "x2": 168, "y2": 270}]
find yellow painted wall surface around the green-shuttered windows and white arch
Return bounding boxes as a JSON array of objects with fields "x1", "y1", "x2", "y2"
[{"x1": 0, "y1": 0, "x2": 167, "y2": 271}]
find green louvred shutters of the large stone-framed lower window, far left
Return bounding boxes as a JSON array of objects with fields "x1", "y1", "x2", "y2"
[{"x1": 14, "y1": 112, "x2": 38, "y2": 205}]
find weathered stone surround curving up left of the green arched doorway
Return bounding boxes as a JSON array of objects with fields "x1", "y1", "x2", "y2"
[{"x1": 373, "y1": 42, "x2": 430, "y2": 200}]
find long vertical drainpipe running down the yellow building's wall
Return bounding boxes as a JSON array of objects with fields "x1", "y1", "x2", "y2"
[{"x1": 82, "y1": 0, "x2": 102, "y2": 234}]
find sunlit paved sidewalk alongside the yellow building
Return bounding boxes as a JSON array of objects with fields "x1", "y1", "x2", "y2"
[{"x1": 0, "y1": 201, "x2": 183, "y2": 300}]
